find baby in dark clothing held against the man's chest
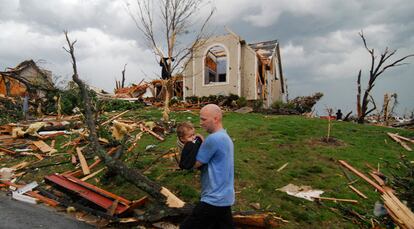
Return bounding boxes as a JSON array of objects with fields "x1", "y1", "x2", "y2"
[{"x1": 177, "y1": 122, "x2": 203, "y2": 170}]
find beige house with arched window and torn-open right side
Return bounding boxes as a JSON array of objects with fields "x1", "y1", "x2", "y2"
[{"x1": 183, "y1": 32, "x2": 285, "y2": 107}]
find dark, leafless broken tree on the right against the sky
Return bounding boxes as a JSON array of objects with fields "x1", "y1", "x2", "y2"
[{"x1": 357, "y1": 31, "x2": 414, "y2": 124}]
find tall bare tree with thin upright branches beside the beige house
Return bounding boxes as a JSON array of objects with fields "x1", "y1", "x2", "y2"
[{"x1": 130, "y1": 0, "x2": 214, "y2": 121}]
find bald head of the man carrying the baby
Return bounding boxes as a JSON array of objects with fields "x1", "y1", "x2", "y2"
[{"x1": 200, "y1": 104, "x2": 223, "y2": 133}]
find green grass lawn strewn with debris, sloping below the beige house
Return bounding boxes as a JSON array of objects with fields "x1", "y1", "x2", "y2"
[{"x1": 0, "y1": 109, "x2": 414, "y2": 228}]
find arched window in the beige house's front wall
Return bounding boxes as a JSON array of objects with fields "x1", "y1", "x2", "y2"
[{"x1": 204, "y1": 45, "x2": 227, "y2": 84}]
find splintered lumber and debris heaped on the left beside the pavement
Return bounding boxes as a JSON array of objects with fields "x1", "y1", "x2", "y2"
[{"x1": 0, "y1": 111, "x2": 285, "y2": 228}]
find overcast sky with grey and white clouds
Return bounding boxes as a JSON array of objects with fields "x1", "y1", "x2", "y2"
[{"x1": 0, "y1": 0, "x2": 414, "y2": 115}]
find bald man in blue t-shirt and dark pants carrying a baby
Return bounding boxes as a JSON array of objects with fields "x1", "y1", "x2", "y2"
[{"x1": 180, "y1": 104, "x2": 235, "y2": 229}]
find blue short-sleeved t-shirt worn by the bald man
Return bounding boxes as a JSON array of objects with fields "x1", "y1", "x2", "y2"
[{"x1": 197, "y1": 129, "x2": 234, "y2": 206}]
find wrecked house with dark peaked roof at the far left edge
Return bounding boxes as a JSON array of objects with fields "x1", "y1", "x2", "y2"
[{"x1": 0, "y1": 60, "x2": 55, "y2": 97}]
